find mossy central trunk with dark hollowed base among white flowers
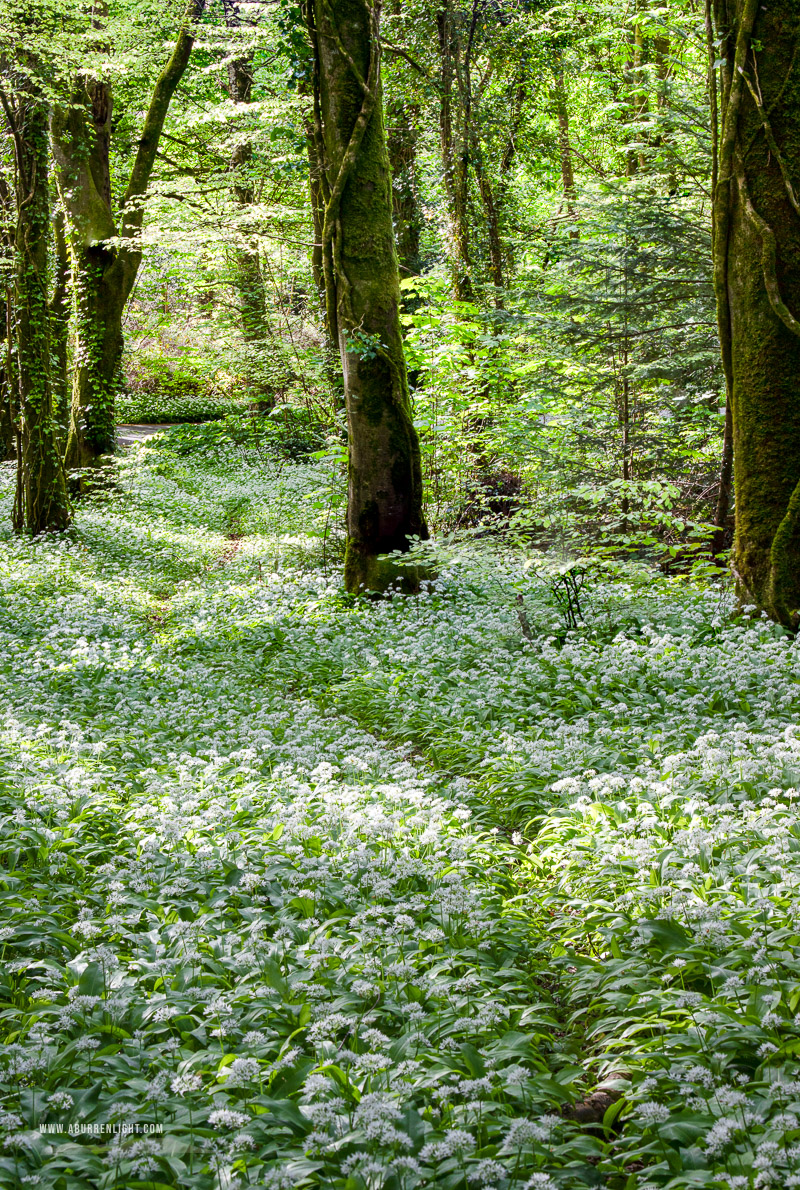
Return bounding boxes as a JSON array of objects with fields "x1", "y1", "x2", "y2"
[{"x1": 306, "y1": 0, "x2": 427, "y2": 593}]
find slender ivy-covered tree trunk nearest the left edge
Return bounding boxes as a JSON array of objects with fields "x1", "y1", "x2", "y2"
[{"x1": 13, "y1": 96, "x2": 71, "y2": 533}]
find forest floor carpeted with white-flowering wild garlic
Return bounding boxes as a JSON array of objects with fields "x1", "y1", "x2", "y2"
[{"x1": 0, "y1": 430, "x2": 800, "y2": 1190}]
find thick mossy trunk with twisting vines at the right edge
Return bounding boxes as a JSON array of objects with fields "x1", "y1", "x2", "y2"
[{"x1": 714, "y1": 0, "x2": 800, "y2": 627}]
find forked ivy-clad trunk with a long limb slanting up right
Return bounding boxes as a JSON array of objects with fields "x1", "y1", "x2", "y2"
[{"x1": 51, "y1": 0, "x2": 205, "y2": 468}]
